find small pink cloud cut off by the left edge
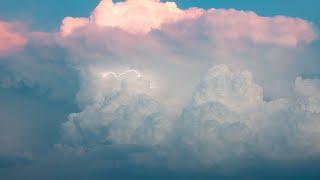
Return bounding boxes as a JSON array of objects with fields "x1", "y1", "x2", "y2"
[{"x1": 0, "y1": 21, "x2": 27, "y2": 56}]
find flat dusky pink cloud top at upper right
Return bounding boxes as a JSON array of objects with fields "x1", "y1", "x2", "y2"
[{"x1": 204, "y1": 9, "x2": 317, "y2": 47}]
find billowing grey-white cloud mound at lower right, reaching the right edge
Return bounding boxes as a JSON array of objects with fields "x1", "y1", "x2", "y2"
[{"x1": 177, "y1": 66, "x2": 320, "y2": 166}]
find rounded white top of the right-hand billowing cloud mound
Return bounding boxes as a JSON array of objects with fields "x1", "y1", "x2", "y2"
[{"x1": 194, "y1": 65, "x2": 263, "y2": 112}]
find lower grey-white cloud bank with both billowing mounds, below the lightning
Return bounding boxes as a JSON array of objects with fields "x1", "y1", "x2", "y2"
[{"x1": 56, "y1": 62, "x2": 320, "y2": 168}]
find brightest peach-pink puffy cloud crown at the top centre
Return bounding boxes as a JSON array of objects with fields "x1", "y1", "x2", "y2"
[{"x1": 61, "y1": 0, "x2": 203, "y2": 35}]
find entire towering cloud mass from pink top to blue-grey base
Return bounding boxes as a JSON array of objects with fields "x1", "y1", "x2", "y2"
[{"x1": 0, "y1": 0, "x2": 320, "y2": 178}]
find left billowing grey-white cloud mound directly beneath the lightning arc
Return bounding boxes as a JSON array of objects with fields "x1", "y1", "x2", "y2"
[{"x1": 59, "y1": 70, "x2": 171, "y2": 150}]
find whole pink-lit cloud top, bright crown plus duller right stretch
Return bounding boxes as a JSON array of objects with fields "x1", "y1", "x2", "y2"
[{"x1": 61, "y1": 0, "x2": 317, "y2": 47}]
